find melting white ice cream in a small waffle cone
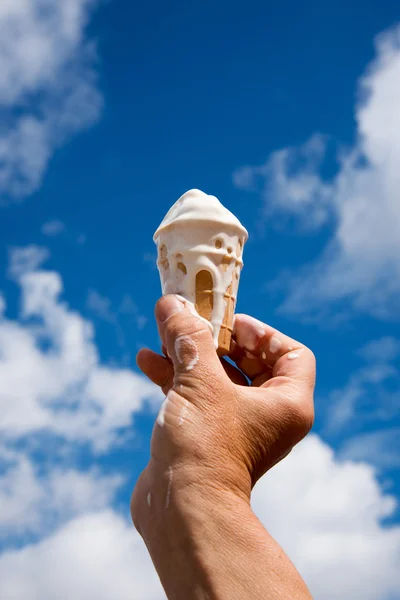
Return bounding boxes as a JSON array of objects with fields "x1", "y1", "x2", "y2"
[{"x1": 154, "y1": 190, "x2": 248, "y2": 354}]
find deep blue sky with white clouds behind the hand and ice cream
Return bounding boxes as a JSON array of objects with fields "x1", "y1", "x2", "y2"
[{"x1": 0, "y1": 0, "x2": 400, "y2": 600}]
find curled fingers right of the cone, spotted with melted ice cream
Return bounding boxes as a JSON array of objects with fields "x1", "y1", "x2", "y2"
[{"x1": 229, "y1": 314, "x2": 315, "y2": 394}]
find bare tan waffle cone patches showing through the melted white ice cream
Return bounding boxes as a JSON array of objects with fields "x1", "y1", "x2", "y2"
[{"x1": 196, "y1": 271, "x2": 235, "y2": 356}]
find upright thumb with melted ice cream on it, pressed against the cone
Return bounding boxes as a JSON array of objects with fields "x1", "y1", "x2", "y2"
[{"x1": 156, "y1": 294, "x2": 227, "y2": 387}]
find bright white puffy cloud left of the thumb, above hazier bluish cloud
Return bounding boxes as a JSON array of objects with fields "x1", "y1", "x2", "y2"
[{"x1": 0, "y1": 251, "x2": 161, "y2": 451}]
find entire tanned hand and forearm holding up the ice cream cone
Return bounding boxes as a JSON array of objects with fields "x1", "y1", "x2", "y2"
[{"x1": 131, "y1": 295, "x2": 315, "y2": 600}]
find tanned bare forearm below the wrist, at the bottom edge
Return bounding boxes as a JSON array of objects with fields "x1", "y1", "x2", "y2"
[{"x1": 140, "y1": 474, "x2": 311, "y2": 600}]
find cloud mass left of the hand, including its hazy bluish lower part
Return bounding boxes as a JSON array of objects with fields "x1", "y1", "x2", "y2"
[{"x1": 0, "y1": 246, "x2": 161, "y2": 546}]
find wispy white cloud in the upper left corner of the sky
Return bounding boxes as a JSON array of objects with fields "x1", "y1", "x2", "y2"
[{"x1": 0, "y1": 0, "x2": 102, "y2": 202}]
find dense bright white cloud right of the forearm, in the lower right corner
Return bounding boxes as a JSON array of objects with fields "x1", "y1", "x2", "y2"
[{"x1": 252, "y1": 435, "x2": 400, "y2": 600}]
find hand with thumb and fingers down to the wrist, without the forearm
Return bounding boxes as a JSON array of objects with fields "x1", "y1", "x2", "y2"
[{"x1": 132, "y1": 295, "x2": 315, "y2": 521}]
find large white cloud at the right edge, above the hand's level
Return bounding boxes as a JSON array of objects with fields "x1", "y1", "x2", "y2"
[{"x1": 235, "y1": 26, "x2": 400, "y2": 318}]
